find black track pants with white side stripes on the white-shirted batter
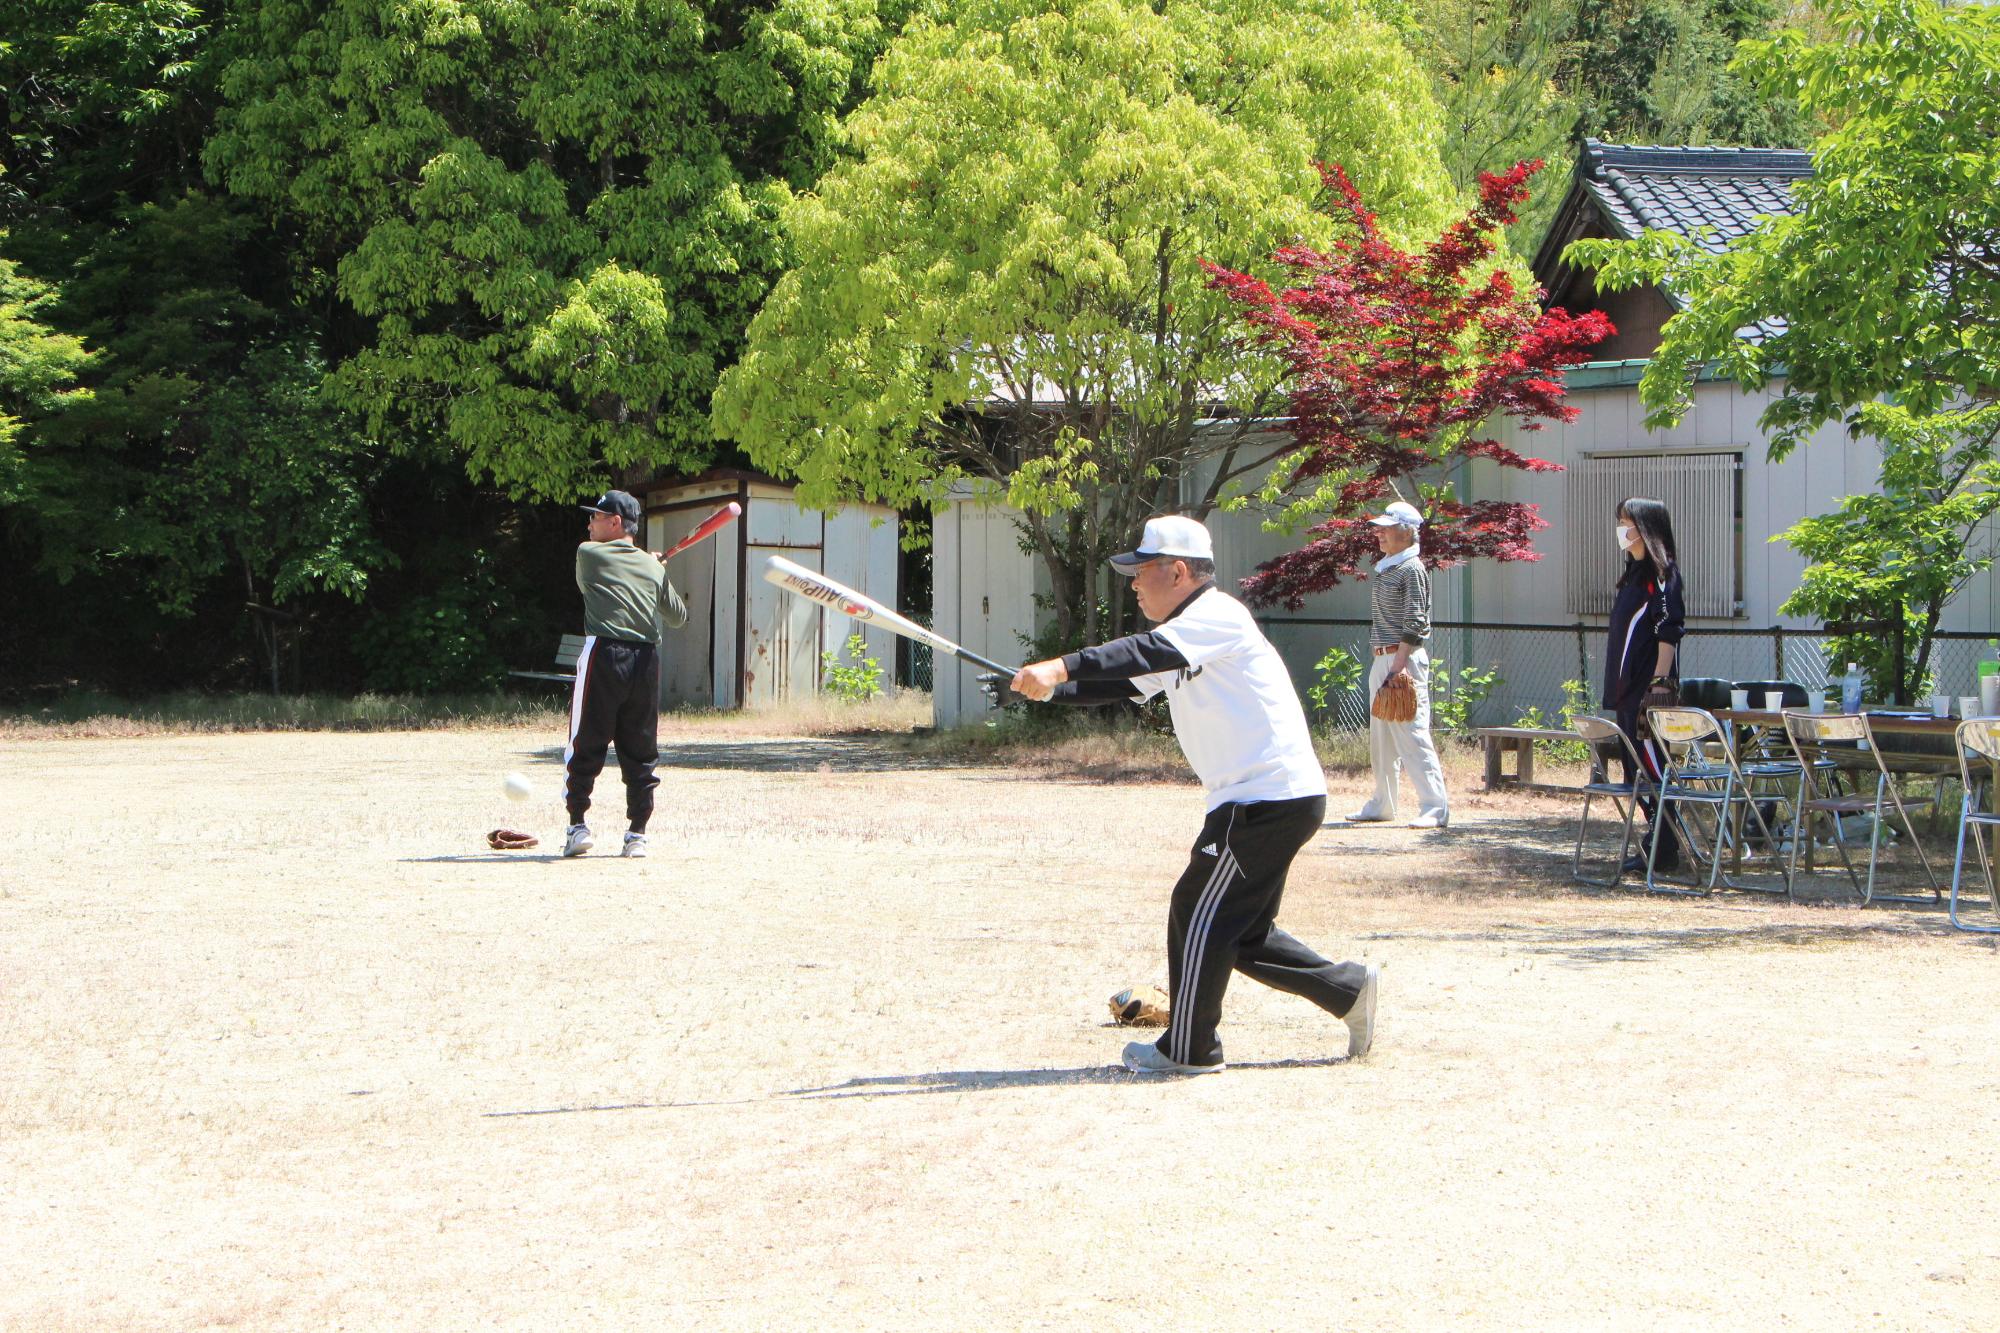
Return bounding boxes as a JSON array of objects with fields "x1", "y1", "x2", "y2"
[{"x1": 1158, "y1": 797, "x2": 1368, "y2": 1065}]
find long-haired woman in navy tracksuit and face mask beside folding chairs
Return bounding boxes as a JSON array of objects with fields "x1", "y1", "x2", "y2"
[{"x1": 1604, "y1": 496, "x2": 1686, "y2": 871}]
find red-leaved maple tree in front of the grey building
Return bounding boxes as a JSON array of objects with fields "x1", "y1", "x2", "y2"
[{"x1": 1204, "y1": 158, "x2": 1612, "y2": 610}]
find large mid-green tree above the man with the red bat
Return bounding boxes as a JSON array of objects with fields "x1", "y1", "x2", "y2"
[{"x1": 208, "y1": 0, "x2": 906, "y2": 496}]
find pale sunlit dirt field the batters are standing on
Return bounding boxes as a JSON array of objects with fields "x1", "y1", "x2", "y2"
[{"x1": 0, "y1": 729, "x2": 2000, "y2": 1333}]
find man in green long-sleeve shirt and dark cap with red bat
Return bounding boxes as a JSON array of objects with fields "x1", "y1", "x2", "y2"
[{"x1": 562, "y1": 490, "x2": 688, "y2": 857}]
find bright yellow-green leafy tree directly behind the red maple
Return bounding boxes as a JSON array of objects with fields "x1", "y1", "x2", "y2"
[{"x1": 714, "y1": 0, "x2": 1456, "y2": 642}]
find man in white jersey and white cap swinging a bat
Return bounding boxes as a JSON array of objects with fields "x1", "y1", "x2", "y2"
[{"x1": 1008, "y1": 516, "x2": 1380, "y2": 1075}]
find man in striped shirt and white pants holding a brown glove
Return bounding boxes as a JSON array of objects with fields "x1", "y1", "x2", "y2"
[{"x1": 1348, "y1": 500, "x2": 1452, "y2": 829}]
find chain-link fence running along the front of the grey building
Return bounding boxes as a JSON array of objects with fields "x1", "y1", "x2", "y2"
[{"x1": 1258, "y1": 618, "x2": 2000, "y2": 729}]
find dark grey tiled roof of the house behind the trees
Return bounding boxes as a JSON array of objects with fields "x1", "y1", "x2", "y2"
[{"x1": 1536, "y1": 138, "x2": 1812, "y2": 338}]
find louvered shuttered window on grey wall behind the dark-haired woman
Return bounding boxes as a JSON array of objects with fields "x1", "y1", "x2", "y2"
[{"x1": 1562, "y1": 454, "x2": 1742, "y2": 616}]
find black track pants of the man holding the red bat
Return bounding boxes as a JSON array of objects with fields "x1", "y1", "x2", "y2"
[{"x1": 562, "y1": 636, "x2": 660, "y2": 833}]
